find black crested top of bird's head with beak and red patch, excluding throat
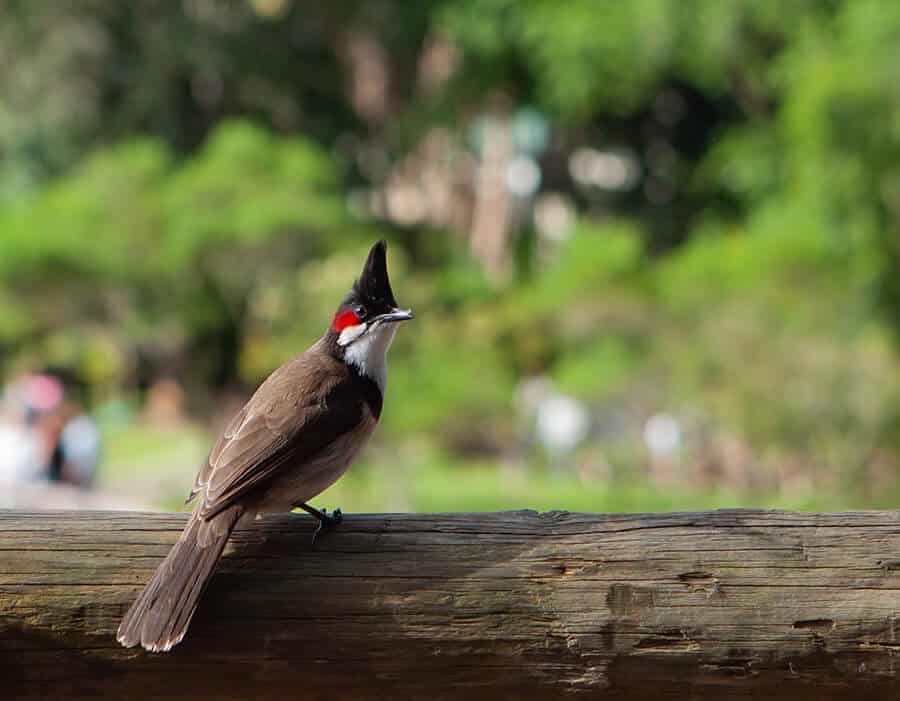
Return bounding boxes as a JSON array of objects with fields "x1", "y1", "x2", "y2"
[{"x1": 331, "y1": 241, "x2": 413, "y2": 339}]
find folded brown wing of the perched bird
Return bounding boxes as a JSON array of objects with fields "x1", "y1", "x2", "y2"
[{"x1": 192, "y1": 354, "x2": 362, "y2": 519}]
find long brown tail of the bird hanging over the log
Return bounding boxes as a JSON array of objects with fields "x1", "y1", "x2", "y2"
[{"x1": 116, "y1": 505, "x2": 243, "y2": 652}]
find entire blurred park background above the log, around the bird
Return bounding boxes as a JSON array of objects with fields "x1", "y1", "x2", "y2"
[{"x1": 0, "y1": 0, "x2": 900, "y2": 511}]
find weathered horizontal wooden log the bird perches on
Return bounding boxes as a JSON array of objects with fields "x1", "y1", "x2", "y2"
[{"x1": 0, "y1": 511, "x2": 900, "y2": 701}]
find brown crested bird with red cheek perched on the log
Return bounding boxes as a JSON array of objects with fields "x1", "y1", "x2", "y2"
[{"x1": 116, "y1": 241, "x2": 413, "y2": 652}]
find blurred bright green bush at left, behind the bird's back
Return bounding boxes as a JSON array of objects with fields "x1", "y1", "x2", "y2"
[{"x1": 0, "y1": 122, "x2": 360, "y2": 394}]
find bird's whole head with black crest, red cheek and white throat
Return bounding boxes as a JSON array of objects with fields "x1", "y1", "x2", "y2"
[{"x1": 330, "y1": 241, "x2": 413, "y2": 388}]
